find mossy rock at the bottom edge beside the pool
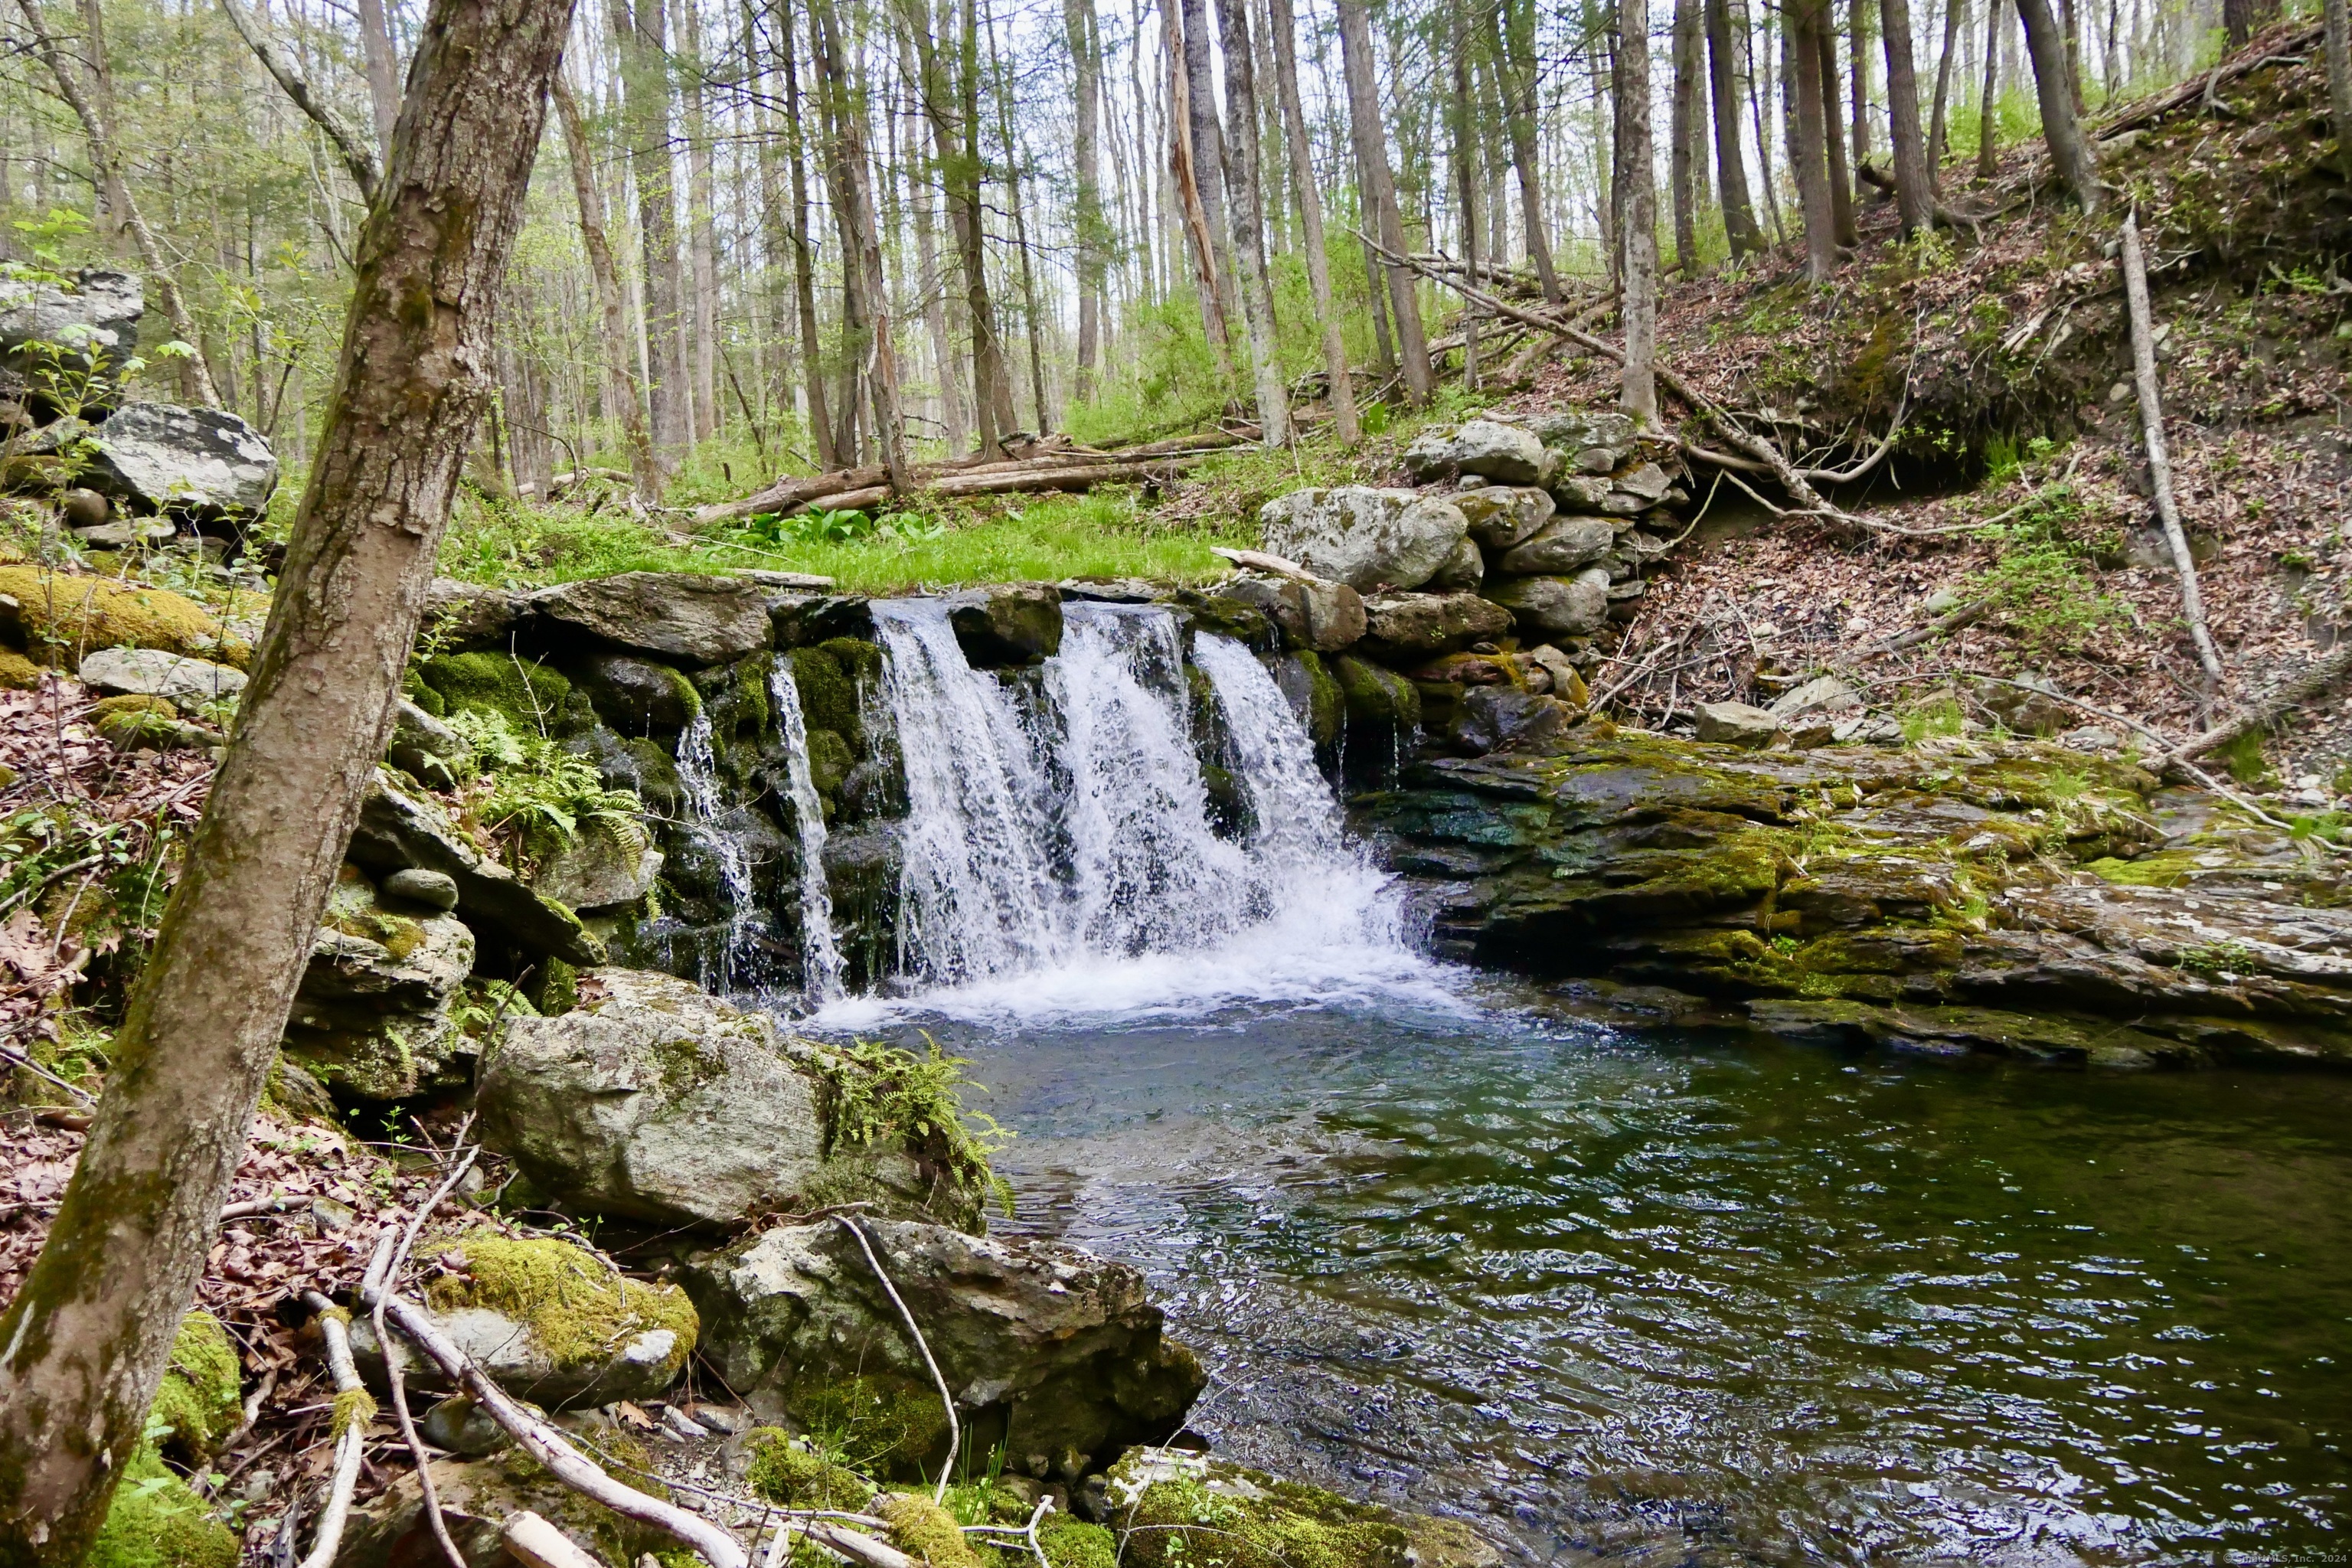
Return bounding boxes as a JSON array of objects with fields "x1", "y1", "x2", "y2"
[{"x1": 1108, "y1": 1448, "x2": 1503, "y2": 1568}]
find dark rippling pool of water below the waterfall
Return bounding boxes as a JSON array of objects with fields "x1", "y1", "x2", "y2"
[{"x1": 832, "y1": 980, "x2": 2352, "y2": 1563}]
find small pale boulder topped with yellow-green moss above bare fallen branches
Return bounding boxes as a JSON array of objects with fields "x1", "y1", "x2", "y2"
[{"x1": 351, "y1": 1230, "x2": 701, "y2": 1408}]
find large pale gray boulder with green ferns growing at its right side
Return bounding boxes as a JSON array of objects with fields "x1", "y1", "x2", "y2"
[{"x1": 475, "y1": 969, "x2": 920, "y2": 1225}]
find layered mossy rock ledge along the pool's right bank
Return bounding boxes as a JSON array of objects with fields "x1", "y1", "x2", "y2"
[{"x1": 1357, "y1": 720, "x2": 2352, "y2": 1067}]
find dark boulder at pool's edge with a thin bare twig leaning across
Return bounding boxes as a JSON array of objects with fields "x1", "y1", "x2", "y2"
[{"x1": 684, "y1": 1220, "x2": 1204, "y2": 1481}]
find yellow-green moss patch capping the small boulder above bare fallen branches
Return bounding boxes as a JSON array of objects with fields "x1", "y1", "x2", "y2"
[{"x1": 426, "y1": 1230, "x2": 701, "y2": 1373}]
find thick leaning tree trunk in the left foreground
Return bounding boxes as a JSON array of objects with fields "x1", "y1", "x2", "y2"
[{"x1": 0, "y1": 0, "x2": 571, "y2": 1568}]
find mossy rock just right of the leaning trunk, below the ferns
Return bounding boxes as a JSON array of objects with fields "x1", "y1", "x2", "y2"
[{"x1": 285, "y1": 865, "x2": 472, "y2": 1100}]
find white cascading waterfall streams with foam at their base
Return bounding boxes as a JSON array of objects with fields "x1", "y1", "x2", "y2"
[{"x1": 816, "y1": 599, "x2": 1461, "y2": 1030}]
